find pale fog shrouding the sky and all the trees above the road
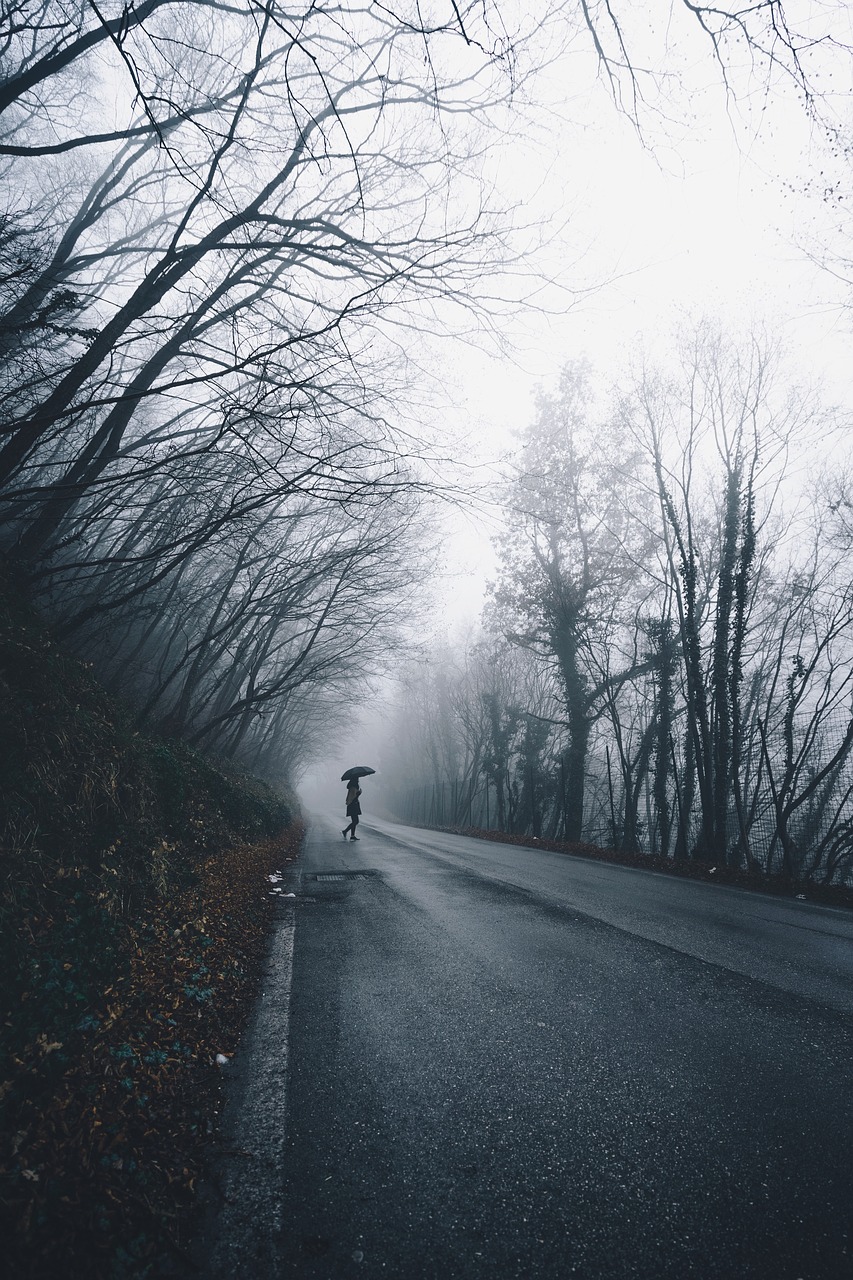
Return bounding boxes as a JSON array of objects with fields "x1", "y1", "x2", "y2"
[{"x1": 0, "y1": 0, "x2": 853, "y2": 874}]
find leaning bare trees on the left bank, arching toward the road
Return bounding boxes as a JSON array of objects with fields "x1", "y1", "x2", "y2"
[{"x1": 0, "y1": 0, "x2": 555, "y2": 773}]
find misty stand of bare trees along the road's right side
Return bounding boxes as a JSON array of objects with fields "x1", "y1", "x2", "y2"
[{"x1": 379, "y1": 337, "x2": 853, "y2": 884}]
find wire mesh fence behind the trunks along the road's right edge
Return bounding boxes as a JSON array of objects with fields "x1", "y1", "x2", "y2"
[{"x1": 394, "y1": 709, "x2": 853, "y2": 884}]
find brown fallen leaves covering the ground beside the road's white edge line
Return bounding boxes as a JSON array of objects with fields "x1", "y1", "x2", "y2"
[{"x1": 0, "y1": 824, "x2": 301, "y2": 1280}]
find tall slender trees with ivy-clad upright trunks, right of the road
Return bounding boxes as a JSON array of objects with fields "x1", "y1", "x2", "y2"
[{"x1": 629, "y1": 325, "x2": 815, "y2": 860}]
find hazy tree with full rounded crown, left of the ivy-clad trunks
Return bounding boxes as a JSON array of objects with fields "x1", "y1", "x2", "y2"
[{"x1": 484, "y1": 365, "x2": 644, "y2": 840}]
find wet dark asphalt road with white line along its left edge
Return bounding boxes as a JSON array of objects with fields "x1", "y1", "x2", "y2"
[{"x1": 204, "y1": 819, "x2": 853, "y2": 1280}]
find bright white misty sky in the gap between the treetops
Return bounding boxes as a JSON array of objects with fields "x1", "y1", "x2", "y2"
[{"x1": 305, "y1": 6, "x2": 853, "y2": 803}]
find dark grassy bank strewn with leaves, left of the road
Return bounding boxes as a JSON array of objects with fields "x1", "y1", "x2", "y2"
[{"x1": 0, "y1": 582, "x2": 298, "y2": 1277}]
